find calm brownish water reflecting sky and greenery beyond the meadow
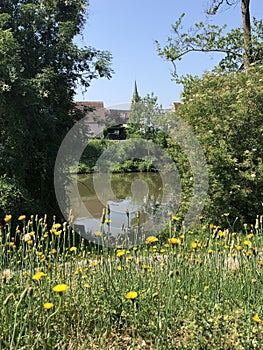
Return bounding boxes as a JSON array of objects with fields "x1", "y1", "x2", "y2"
[{"x1": 71, "y1": 173, "x2": 180, "y2": 243}]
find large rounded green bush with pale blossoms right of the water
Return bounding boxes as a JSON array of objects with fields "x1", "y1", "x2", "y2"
[{"x1": 167, "y1": 67, "x2": 263, "y2": 223}]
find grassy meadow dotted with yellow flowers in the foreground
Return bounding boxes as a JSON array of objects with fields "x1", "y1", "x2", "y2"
[{"x1": 0, "y1": 216, "x2": 263, "y2": 350}]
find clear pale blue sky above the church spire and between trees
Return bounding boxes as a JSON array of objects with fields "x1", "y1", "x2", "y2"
[{"x1": 75, "y1": 0, "x2": 263, "y2": 109}]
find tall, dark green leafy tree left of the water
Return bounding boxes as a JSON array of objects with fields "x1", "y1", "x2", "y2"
[{"x1": 0, "y1": 0, "x2": 112, "y2": 217}]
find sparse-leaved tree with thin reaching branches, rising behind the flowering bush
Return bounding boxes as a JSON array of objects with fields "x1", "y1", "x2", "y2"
[{"x1": 156, "y1": 0, "x2": 263, "y2": 77}]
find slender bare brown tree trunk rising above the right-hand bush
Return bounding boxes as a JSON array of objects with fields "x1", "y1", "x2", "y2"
[{"x1": 241, "y1": 0, "x2": 252, "y2": 71}]
